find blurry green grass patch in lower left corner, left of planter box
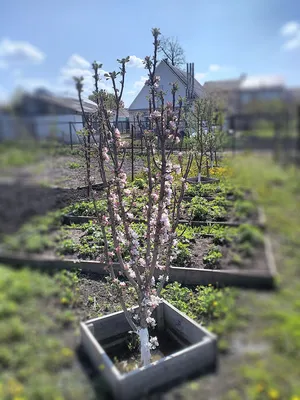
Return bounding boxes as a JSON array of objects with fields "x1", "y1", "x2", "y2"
[{"x1": 0, "y1": 265, "x2": 101, "y2": 400}]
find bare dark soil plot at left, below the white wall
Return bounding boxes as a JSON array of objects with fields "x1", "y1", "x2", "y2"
[{"x1": 0, "y1": 155, "x2": 143, "y2": 238}]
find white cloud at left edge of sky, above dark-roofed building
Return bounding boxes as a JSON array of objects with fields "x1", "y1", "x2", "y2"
[{"x1": 0, "y1": 38, "x2": 46, "y2": 68}]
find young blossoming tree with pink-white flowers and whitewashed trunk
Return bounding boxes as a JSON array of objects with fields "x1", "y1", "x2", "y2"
[{"x1": 75, "y1": 28, "x2": 193, "y2": 365}]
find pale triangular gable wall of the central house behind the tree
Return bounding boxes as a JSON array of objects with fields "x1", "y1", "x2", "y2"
[{"x1": 129, "y1": 62, "x2": 186, "y2": 115}]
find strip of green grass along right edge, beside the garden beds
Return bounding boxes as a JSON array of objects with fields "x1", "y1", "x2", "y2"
[{"x1": 218, "y1": 155, "x2": 300, "y2": 400}]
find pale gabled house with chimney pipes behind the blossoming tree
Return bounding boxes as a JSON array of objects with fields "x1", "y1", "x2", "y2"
[{"x1": 128, "y1": 60, "x2": 205, "y2": 121}]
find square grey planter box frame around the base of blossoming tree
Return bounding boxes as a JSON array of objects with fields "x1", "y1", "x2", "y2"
[{"x1": 80, "y1": 301, "x2": 217, "y2": 400}]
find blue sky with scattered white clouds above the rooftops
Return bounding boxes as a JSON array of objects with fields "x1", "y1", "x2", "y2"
[{"x1": 0, "y1": 0, "x2": 300, "y2": 106}]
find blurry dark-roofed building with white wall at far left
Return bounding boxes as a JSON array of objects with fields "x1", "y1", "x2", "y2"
[{"x1": 0, "y1": 89, "x2": 97, "y2": 143}]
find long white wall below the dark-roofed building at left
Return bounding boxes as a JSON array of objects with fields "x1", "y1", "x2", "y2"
[{"x1": 0, "y1": 114, "x2": 83, "y2": 143}]
